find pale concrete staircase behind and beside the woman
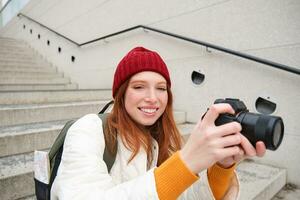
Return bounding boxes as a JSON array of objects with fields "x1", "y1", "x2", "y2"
[{"x1": 0, "y1": 38, "x2": 286, "y2": 200}]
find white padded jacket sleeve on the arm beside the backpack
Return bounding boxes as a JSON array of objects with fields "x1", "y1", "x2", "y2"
[{"x1": 51, "y1": 114, "x2": 158, "y2": 200}]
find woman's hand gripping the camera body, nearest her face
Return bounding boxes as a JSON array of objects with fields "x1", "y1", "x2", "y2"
[{"x1": 180, "y1": 103, "x2": 243, "y2": 174}]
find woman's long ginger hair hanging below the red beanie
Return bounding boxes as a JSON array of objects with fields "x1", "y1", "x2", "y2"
[{"x1": 105, "y1": 79, "x2": 182, "y2": 167}]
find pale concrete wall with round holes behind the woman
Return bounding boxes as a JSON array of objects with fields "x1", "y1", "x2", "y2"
[{"x1": 0, "y1": 0, "x2": 300, "y2": 185}]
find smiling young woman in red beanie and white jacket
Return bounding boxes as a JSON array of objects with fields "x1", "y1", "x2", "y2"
[{"x1": 51, "y1": 47, "x2": 266, "y2": 200}]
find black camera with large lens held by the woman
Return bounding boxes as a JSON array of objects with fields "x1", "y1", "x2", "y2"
[{"x1": 214, "y1": 98, "x2": 284, "y2": 151}]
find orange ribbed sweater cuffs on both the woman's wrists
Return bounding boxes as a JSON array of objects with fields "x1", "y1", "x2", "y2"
[{"x1": 154, "y1": 152, "x2": 235, "y2": 200}]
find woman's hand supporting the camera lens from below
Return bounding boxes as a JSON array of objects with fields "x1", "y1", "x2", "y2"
[{"x1": 218, "y1": 133, "x2": 266, "y2": 168}]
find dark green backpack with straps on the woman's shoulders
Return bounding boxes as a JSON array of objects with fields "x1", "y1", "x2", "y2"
[{"x1": 34, "y1": 101, "x2": 117, "y2": 200}]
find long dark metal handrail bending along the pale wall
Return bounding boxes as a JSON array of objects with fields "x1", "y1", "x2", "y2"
[{"x1": 18, "y1": 13, "x2": 300, "y2": 75}]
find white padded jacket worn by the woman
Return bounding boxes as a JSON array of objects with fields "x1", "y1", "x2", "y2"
[{"x1": 51, "y1": 114, "x2": 238, "y2": 200}]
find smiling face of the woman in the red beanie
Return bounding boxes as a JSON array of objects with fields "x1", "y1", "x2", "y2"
[{"x1": 125, "y1": 71, "x2": 168, "y2": 126}]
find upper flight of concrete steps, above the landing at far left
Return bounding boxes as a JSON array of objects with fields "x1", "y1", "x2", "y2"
[{"x1": 0, "y1": 38, "x2": 77, "y2": 91}]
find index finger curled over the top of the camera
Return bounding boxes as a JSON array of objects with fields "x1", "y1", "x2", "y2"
[{"x1": 202, "y1": 103, "x2": 234, "y2": 124}]
